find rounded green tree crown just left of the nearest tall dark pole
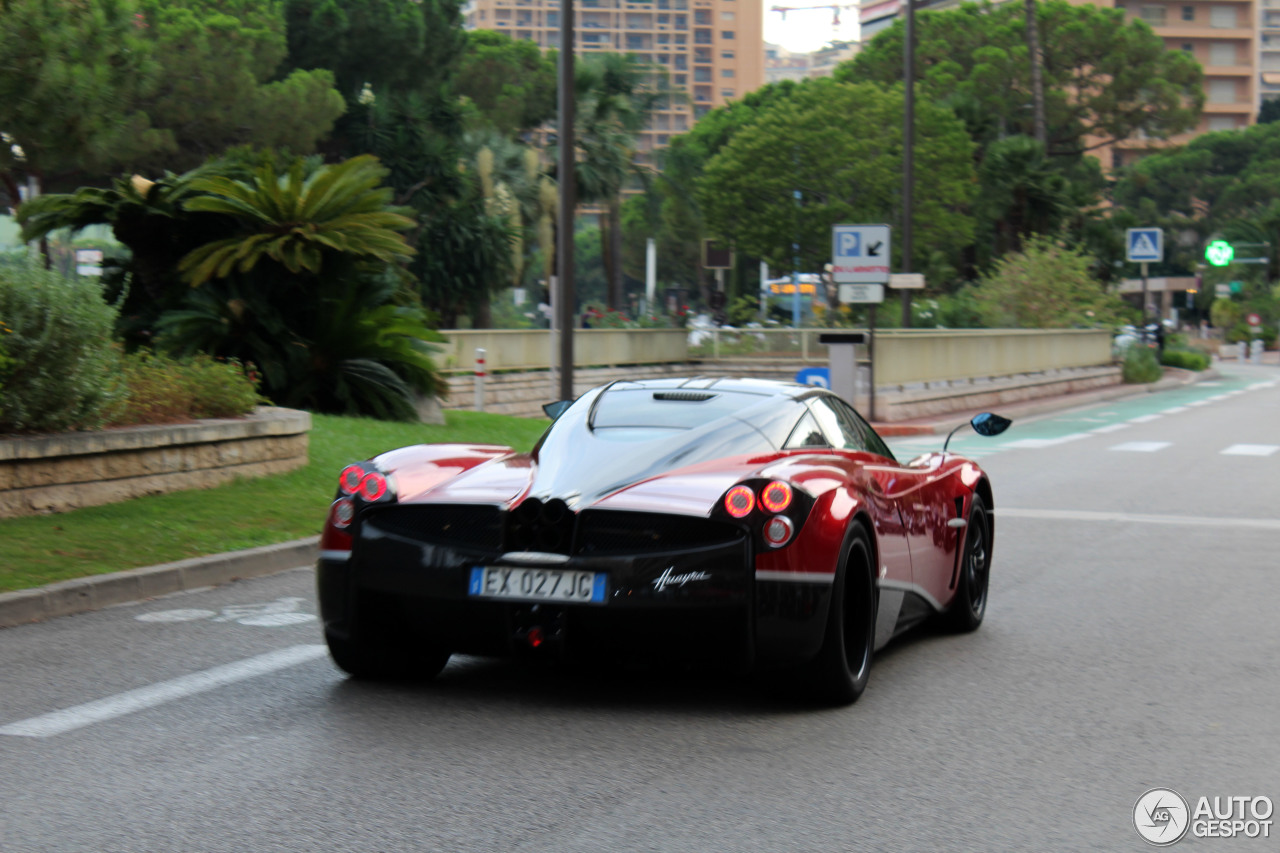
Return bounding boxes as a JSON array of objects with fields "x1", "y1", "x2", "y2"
[{"x1": 453, "y1": 29, "x2": 556, "y2": 136}]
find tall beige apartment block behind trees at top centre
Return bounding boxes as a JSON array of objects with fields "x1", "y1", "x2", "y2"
[{"x1": 463, "y1": 0, "x2": 764, "y2": 152}]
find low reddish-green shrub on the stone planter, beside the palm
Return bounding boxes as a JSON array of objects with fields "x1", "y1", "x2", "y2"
[{"x1": 111, "y1": 351, "x2": 260, "y2": 427}]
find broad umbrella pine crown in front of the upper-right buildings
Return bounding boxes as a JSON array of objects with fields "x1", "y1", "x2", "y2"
[{"x1": 835, "y1": 0, "x2": 1204, "y2": 156}]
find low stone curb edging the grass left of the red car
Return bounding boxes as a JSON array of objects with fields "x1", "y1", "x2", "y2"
[{"x1": 0, "y1": 537, "x2": 320, "y2": 629}]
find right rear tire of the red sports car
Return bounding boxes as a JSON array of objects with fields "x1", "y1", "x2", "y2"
[{"x1": 812, "y1": 524, "x2": 877, "y2": 706}]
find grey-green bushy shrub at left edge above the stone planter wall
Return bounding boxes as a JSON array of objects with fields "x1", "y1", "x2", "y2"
[{"x1": 0, "y1": 260, "x2": 123, "y2": 433}]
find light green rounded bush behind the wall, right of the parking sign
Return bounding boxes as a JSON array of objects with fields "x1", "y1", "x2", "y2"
[{"x1": 970, "y1": 236, "x2": 1129, "y2": 329}]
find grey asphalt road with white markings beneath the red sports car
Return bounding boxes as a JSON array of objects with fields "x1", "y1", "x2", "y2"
[{"x1": 0, "y1": 368, "x2": 1280, "y2": 853}]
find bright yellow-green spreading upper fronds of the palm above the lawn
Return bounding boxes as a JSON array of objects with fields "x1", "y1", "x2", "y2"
[{"x1": 178, "y1": 155, "x2": 415, "y2": 287}]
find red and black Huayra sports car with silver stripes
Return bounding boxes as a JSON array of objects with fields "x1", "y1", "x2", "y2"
[{"x1": 317, "y1": 378, "x2": 1009, "y2": 703}]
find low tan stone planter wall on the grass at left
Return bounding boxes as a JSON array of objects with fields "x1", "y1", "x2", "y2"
[{"x1": 0, "y1": 406, "x2": 311, "y2": 517}]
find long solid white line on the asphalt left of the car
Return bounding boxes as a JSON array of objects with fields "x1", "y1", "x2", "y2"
[{"x1": 0, "y1": 646, "x2": 325, "y2": 738}]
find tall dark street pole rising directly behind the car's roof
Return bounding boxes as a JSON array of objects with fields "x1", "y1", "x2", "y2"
[{"x1": 556, "y1": 0, "x2": 577, "y2": 400}]
